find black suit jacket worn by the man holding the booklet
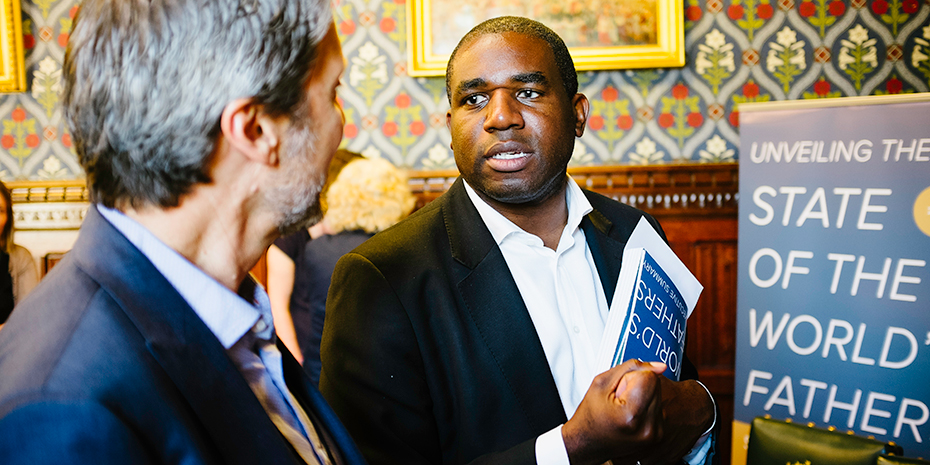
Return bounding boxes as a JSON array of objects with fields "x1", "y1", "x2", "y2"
[{"x1": 320, "y1": 179, "x2": 696, "y2": 464}]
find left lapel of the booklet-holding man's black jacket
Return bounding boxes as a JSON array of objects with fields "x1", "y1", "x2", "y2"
[{"x1": 442, "y1": 179, "x2": 566, "y2": 434}]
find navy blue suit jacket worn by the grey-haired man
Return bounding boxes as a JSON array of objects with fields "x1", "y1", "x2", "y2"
[{"x1": 0, "y1": 207, "x2": 364, "y2": 464}]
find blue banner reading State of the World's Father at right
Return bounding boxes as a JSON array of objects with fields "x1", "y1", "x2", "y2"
[{"x1": 733, "y1": 93, "x2": 930, "y2": 464}]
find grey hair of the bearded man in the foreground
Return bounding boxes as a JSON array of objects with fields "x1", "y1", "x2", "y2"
[{"x1": 63, "y1": 0, "x2": 332, "y2": 207}]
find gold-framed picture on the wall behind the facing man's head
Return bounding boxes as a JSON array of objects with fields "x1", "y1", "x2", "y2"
[{"x1": 407, "y1": 0, "x2": 685, "y2": 77}]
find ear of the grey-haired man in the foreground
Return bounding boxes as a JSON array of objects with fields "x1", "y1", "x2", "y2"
[{"x1": 220, "y1": 98, "x2": 281, "y2": 166}]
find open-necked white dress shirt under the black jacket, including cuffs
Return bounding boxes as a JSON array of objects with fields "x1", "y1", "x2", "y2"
[{"x1": 465, "y1": 176, "x2": 716, "y2": 465}]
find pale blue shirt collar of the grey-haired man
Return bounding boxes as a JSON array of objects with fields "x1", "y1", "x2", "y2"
[{"x1": 97, "y1": 205, "x2": 266, "y2": 349}]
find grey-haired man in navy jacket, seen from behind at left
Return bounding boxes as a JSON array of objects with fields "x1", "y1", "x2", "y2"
[{"x1": 0, "y1": 0, "x2": 364, "y2": 464}]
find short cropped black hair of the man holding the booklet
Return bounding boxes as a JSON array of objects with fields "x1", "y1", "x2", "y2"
[{"x1": 446, "y1": 16, "x2": 578, "y2": 103}]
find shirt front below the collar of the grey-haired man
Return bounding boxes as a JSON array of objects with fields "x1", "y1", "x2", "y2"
[{"x1": 229, "y1": 319, "x2": 331, "y2": 465}]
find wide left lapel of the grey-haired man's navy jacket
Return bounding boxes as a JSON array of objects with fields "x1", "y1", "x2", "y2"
[{"x1": 72, "y1": 207, "x2": 296, "y2": 463}]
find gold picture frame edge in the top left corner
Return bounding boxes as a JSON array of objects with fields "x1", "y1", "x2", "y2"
[{"x1": 0, "y1": 0, "x2": 26, "y2": 93}]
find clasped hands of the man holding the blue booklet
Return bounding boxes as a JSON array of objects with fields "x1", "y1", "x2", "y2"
[{"x1": 562, "y1": 360, "x2": 714, "y2": 465}]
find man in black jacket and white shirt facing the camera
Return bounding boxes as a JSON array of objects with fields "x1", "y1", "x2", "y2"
[{"x1": 320, "y1": 17, "x2": 714, "y2": 465}]
